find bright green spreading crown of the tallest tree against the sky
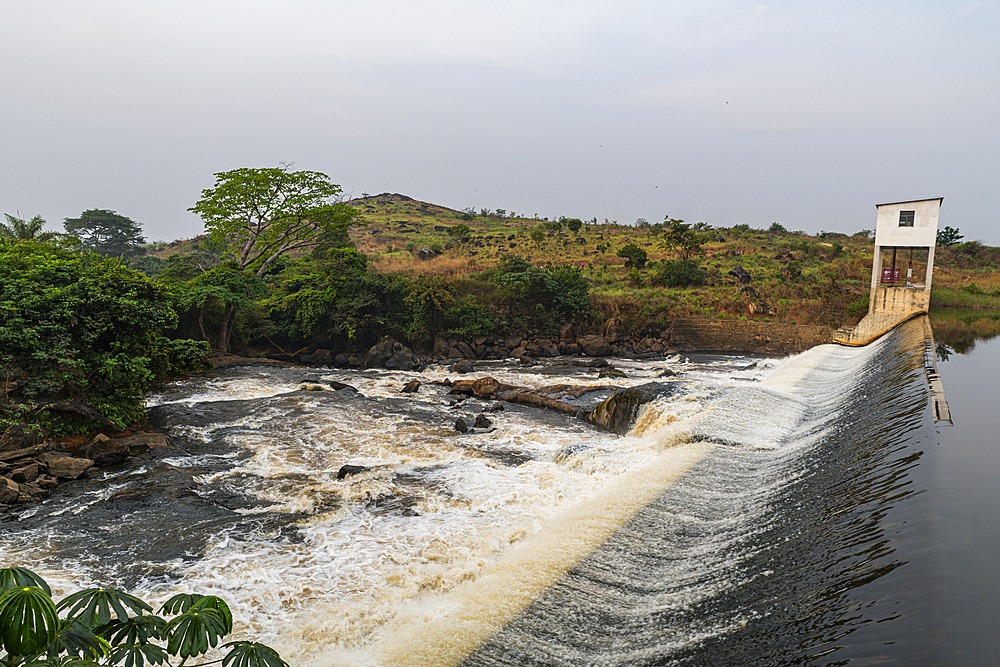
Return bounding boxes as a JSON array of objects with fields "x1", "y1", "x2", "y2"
[{"x1": 188, "y1": 165, "x2": 358, "y2": 276}]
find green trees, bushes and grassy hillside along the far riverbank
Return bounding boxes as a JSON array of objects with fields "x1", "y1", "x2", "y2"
[{"x1": 0, "y1": 172, "x2": 1000, "y2": 432}]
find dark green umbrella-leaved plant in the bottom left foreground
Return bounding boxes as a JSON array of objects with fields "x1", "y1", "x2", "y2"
[{"x1": 0, "y1": 568, "x2": 288, "y2": 667}]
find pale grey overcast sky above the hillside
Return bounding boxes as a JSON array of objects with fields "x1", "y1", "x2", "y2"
[{"x1": 0, "y1": 0, "x2": 1000, "y2": 245}]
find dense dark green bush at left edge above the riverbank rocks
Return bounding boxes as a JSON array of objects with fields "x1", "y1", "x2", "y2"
[{"x1": 0, "y1": 242, "x2": 184, "y2": 427}]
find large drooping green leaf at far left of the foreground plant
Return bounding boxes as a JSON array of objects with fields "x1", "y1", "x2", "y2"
[{"x1": 0, "y1": 586, "x2": 59, "y2": 656}]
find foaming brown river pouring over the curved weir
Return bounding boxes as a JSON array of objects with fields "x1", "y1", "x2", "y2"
[{"x1": 0, "y1": 320, "x2": 1000, "y2": 666}]
